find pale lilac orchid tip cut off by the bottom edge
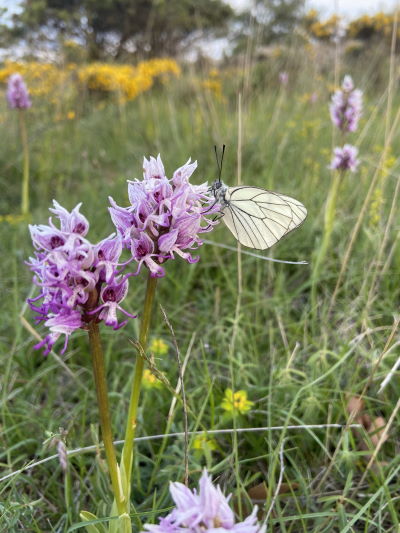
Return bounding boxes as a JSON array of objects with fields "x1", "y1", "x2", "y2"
[{"x1": 142, "y1": 470, "x2": 265, "y2": 533}]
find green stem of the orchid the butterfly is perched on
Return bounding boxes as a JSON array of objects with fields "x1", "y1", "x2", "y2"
[{"x1": 121, "y1": 273, "x2": 157, "y2": 502}]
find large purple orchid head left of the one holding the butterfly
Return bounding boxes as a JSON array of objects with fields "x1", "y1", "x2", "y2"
[{"x1": 27, "y1": 201, "x2": 134, "y2": 354}]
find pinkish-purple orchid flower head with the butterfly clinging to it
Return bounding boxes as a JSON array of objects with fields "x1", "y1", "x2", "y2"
[{"x1": 109, "y1": 155, "x2": 219, "y2": 277}]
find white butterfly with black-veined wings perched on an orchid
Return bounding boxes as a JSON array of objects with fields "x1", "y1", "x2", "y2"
[{"x1": 210, "y1": 145, "x2": 307, "y2": 250}]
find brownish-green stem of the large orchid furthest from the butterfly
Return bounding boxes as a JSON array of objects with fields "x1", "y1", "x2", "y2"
[{"x1": 89, "y1": 321, "x2": 126, "y2": 515}]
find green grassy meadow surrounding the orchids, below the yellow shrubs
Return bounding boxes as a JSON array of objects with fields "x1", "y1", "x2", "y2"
[{"x1": 0, "y1": 45, "x2": 400, "y2": 533}]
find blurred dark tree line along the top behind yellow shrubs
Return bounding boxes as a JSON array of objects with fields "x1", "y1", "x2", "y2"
[{"x1": 0, "y1": 0, "x2": 393, "y2": 61}]
